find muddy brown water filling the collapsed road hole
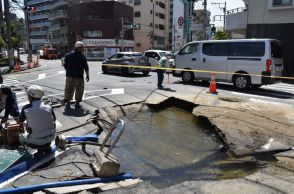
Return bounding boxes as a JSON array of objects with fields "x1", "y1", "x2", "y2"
[{"x1": 113, "y1": 108, "x2": 257, "y2": 188}]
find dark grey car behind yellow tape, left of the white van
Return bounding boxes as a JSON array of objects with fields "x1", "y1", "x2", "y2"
[{"x1": 102, "y1": 52, "x2": 150, "y2": 76}]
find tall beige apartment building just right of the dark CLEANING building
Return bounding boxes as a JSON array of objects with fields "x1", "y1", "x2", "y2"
[{"x1": 118, "y1": 0, "x2": 169, "y2": 52}]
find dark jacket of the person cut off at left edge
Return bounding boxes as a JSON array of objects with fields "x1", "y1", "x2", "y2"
[{"x1": 0, "y1": 86, "x2": 19, "y2": 117}]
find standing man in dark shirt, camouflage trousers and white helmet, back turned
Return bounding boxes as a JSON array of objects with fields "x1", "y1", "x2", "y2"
[{"x1": 64, "y1": 41, "x2": 90, "y2": 109}]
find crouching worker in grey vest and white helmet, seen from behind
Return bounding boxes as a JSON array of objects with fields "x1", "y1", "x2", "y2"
[{"x1": 19, "y1": 85, "x2": 56, "y2": 153}]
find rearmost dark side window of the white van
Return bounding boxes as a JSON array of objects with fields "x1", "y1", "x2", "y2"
[{"x1": 230, "y1": 42, "x2": 265, "y2": 57}]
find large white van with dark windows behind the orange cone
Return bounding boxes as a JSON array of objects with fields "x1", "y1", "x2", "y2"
[{"x1": 173, "y1": 39, "x2": 283, "y2": 90}]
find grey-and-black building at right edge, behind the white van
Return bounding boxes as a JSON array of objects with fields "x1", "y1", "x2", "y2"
[{"x1": 246, "y1": 0, "x2": 294, "y2": 76}]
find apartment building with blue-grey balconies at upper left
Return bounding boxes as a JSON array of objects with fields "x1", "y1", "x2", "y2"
[{"x1": 26, "y1": 0, "x2": 52, "y2": 51}]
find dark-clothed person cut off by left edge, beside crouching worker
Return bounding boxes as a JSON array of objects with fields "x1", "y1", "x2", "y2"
[{"x1": 0, "y1": 85, "x2": 19, "y2": 123}]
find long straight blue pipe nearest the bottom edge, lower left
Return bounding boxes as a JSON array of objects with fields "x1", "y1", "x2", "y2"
[{"x1": 0, "y1": 173, "x2": 133, "y2": 194}]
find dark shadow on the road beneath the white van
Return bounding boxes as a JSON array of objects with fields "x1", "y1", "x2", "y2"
[{"x1": 173, "y1": 81, "x2": 294, "y2": 99}]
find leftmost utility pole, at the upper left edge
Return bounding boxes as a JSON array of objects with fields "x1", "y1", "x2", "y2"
[{"x1": 4, "y1": 0, "x2": 14, "y2": 70}]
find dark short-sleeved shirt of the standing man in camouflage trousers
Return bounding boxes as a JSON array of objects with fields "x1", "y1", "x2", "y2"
[{"x1": 64, "y1": 51, "x2": 89, "y2": 79}]
